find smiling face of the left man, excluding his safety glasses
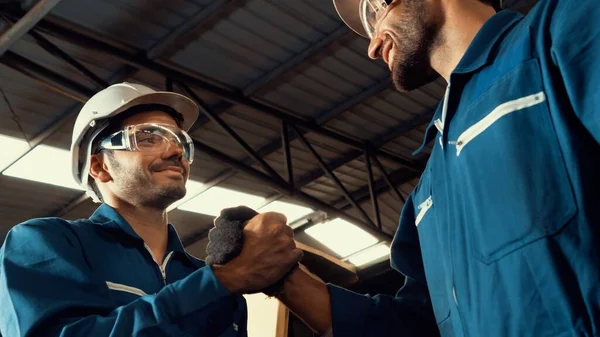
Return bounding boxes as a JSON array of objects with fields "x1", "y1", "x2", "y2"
[{"x1": 90, "y1": 111, "x2": 190, "y2": 209}]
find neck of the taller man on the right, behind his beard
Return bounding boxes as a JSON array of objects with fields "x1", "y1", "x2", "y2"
[{"x1": 431, "y1": 0, "x2": 496, "y2": 82}]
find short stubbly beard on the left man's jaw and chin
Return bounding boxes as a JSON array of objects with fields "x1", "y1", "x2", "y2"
[{"x1": 112, "y1": 160, "x2": 186, "y2": 210}]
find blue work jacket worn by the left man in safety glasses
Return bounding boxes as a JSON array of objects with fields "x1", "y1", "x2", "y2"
[{"x1": 0, "y1": 205, "x2": 247, "y2": 337}]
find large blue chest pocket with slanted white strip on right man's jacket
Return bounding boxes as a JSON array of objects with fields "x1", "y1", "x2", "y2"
[{"x1": 448, "y1": 59, "x2": 576, "y2": 264}]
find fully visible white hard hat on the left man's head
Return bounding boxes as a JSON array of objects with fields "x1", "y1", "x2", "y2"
[{"x1": 71, "y1": 83, "x2": 198, "y2": 202}]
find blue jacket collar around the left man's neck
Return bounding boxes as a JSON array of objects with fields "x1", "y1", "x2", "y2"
[{"x1": 90, "y1": 204, "x2": 185, "y2": 253}]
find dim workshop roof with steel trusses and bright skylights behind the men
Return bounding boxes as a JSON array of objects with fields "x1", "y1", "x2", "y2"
[{"x1": 0, "y1": 0, "x2": 535, "y2": 337}]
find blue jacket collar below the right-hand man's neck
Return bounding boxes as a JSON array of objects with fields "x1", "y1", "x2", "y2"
[{"x1": 413, "y1": 10, "x2": 523, "y2": 155}]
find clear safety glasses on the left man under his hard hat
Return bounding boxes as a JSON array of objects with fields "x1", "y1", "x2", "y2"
[{"x1": 99, "y1": 123, "x2": 194, "y2": 164}]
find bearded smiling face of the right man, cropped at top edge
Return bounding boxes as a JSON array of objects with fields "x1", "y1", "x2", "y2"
[{"x1": 369, "y1": 0, "x2": 443, "y2": 91}]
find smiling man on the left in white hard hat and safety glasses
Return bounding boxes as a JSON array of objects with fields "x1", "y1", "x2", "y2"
[{"x1": 0, "y1": 83, "x2": 301, "y2": 337}]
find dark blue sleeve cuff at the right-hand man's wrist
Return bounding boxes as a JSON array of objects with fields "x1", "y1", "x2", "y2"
[{"x1": 326, "y1": 284, "x2": 373, "y2": 337}]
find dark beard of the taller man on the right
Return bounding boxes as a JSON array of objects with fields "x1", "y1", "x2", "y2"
[{"x1": 389, "y1": 0, "x2": 443, "y2": 91}]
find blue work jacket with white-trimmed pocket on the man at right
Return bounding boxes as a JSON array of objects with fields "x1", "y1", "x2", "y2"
[{"x1": 329, "y1": 0, "x2": 600, "y2": 337}]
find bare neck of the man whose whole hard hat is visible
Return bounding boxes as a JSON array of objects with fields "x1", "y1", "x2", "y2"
[{"x1": 107, "y1": 201, "x2": 168, "y2": 264}]
